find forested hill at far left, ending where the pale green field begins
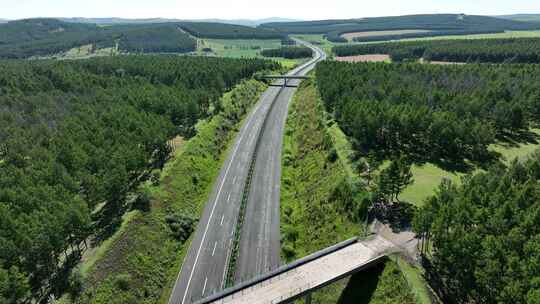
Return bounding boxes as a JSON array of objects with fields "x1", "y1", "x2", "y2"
[{"x1": 0, "y1": 18, "x2": 196, "y2": 58}]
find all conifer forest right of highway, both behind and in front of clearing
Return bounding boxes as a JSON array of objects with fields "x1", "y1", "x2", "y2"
[{"x1": 316, "y1": 62, "x2": 540, "y2": 304}]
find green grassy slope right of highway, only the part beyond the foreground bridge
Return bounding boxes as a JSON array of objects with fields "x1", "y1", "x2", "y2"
[{"x1": 281, "y1": 79, "x2": 360, "y2": 261}]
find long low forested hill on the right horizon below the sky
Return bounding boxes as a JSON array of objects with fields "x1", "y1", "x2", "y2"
[{"x1": 260, "y1": 14, "x2": 540, "y2": 42}]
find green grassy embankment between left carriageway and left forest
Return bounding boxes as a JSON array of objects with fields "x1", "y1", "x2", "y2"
[{"x1": 64, "y1": 80, "x2": 266, "y2": 304}]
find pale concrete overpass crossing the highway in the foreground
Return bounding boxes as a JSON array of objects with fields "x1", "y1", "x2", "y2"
[{"x1": 195, "y1": 236, "x2": 397, "y2": 304}]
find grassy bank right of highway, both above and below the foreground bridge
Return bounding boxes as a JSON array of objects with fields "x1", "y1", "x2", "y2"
[{"x1": 281, "y1": 82, "x2": 424, "y2": 304}]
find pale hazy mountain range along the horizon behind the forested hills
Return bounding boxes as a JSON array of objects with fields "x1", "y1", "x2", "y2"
[{"x1": 57, "y1": 17, "x2": 298, "y2": 27}]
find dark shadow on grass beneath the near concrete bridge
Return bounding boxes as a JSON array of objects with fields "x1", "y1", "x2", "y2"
[{"x1": 337, "y1": 263, "x2": 385, "y2": 304}]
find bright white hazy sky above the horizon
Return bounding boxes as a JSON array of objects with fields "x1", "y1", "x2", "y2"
[{"x1": 0, "y1": 0, "x2": 540, "y2": 19}]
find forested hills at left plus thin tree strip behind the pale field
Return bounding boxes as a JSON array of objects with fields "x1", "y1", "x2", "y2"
[{"x1": 0, "y1": 18, "x2": 283, "y2": 58}]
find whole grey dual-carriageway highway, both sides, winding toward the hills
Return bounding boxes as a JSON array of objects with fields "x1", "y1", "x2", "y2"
[{"x1": 169, "y1": 40, "x2": 324, "y2": 304}]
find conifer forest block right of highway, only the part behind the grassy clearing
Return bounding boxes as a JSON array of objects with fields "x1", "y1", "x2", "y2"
[{"x1": 317, "y1": 62, "x2": 540, "y2": 163}]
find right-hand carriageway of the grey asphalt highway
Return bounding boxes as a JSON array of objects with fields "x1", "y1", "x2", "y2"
[{"x1": 235, "y1": 41, "x2": 325, "y2": 283}]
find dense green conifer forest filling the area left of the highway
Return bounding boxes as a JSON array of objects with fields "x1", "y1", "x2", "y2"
[{"x1": 0, "y1": 56, "x2": 276, "y2": 303}]
